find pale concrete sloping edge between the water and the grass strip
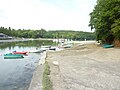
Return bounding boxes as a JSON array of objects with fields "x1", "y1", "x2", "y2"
[{"x1": 28, "y1": 52, "x2": 47, "y2": 90}]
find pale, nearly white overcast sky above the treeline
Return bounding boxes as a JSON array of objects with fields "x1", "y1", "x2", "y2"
[{"x1": 0, "y1": 0, "x2": 96, "y2": 31}]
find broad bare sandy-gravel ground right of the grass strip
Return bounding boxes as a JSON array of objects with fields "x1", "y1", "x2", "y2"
[{"x1": 47, "y1": 44, "x2": 120, "y2": 90}]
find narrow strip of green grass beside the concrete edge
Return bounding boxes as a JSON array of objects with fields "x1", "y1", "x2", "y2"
[{"x1": 42, "y1": 61, "x2": 53, "y2": 90}]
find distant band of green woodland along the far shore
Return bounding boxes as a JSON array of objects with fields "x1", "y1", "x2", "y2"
[{"x1": 0, "y1": 27, "x2": 95, "y2": 40}]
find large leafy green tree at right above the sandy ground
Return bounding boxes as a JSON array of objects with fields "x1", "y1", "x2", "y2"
[{"x1": 89, "y1": 0, "x2": 120, "y2": 43}]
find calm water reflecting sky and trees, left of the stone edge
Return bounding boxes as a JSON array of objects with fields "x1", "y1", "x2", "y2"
[{"x1": 0, "y1": 41, "x2": 52, "y2": 90}]
